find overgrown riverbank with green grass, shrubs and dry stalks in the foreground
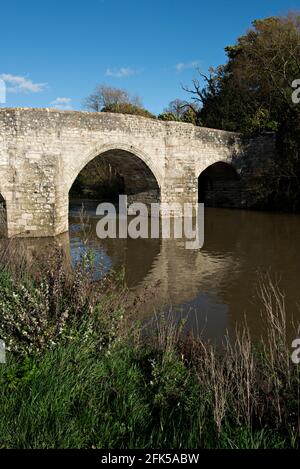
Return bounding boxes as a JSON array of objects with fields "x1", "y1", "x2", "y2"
[{"x1": 0, "y1": 250, "x2": 299, "y2": 448}]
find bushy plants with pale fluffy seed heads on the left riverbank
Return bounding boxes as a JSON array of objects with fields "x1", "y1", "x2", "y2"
[{"x1": 0, "y1": 252, "x2": 125, "y2": 356}]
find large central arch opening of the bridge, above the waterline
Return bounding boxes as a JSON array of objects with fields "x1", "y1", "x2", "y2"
[{"x1": 69, "y1": 148, "x2": 160, "y2": 205}]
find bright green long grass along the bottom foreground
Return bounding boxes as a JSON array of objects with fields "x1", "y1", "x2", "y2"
[{"x1": 0, "y1": 336, "x2": 297, "y2": 449}]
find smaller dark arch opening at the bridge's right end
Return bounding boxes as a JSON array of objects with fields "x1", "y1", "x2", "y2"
[{"x1": 198, "y1": 161, "x2": 241, "y2": 208}]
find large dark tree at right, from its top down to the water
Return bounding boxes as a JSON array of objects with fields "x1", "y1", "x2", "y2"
[{"x1": 185, "y1": 13, "x2": 300, "y2": 210}]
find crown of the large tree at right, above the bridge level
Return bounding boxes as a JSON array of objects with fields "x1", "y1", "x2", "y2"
[{"x1": 185, "y1": 14, "x2": 300, "y2": 132}]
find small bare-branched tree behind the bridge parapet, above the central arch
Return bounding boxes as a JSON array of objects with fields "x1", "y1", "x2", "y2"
[{"x1": 83, "y1": 85, "x2": 142, "y2": 112}]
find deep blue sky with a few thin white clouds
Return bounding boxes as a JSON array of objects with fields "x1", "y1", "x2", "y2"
[{"x1": 0, "y1": 0, "x2": 300, "y2": 113}]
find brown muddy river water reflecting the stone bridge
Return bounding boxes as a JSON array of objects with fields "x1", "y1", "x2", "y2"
[{"x1": 2, "y1": 201, "x2": 300, "y2": 342}]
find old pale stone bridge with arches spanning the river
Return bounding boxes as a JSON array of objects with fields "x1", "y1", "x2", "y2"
[{"x1": 0, "y1": 108, "x2": 275, "y2": 237}]
